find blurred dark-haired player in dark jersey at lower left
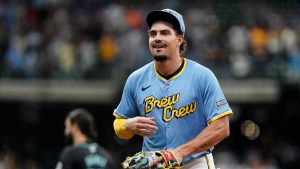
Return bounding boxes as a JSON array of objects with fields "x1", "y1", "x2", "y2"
[{"x1": 56, "y1": 108, "x2": 115, "y2": 169}]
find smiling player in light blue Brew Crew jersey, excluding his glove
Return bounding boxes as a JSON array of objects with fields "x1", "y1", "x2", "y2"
[{"x1": 114, "y1": 9, "x2": 232, "y2": 169}]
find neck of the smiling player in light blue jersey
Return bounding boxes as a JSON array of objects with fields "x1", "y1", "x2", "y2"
[{"x1": 154, "y1": 56, "x2": 183, "y2": 76}]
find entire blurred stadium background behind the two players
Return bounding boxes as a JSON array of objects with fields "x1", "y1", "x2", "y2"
[{"x1": 0, "y1": 0, "x2": 300, "y2": 169}]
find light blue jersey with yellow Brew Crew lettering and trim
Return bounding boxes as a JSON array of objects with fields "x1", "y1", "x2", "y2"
[{"x1": 115, "y1": 59, "x2": 232, "y2": 162}]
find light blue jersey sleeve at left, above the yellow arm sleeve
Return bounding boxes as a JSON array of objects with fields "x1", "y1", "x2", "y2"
[{"x1": 114, "y1": 75, "x2": 138, "y2": 118}]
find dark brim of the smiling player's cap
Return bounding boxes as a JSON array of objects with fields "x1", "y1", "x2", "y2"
[{"x1": 146, "y1": 11, "x2": 182, "y2": 33}]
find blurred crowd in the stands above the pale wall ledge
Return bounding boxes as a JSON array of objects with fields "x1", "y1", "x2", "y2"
[{"x1": 0, "y1": 0, "x2": 300, "y2": 80}]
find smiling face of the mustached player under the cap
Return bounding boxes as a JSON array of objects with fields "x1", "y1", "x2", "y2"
[{"x1": 149, "y1": 21, "x2": 183, "y2": 59}]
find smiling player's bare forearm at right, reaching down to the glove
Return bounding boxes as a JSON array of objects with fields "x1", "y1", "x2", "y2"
[{"x1": 176, "y1": 116, "x2": 230, "y2": 157}]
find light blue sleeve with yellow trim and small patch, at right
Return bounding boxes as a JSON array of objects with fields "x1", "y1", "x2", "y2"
[{"x1": 200, "y1": 69, "x2": 232, "y2": 124}]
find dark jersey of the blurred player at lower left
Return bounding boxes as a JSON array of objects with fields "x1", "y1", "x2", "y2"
[{"x1": 56, "y1": 142, "x2": 114, "y2": 169}]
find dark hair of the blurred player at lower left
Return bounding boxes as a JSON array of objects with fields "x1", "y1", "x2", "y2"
[{"x1": 67, "y1": 108, "x2": 98, "y2": 140}]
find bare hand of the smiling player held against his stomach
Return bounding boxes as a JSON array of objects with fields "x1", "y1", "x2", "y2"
[{"x1": 124, "y1": 116, "x2": 158, "y2": 136}]
